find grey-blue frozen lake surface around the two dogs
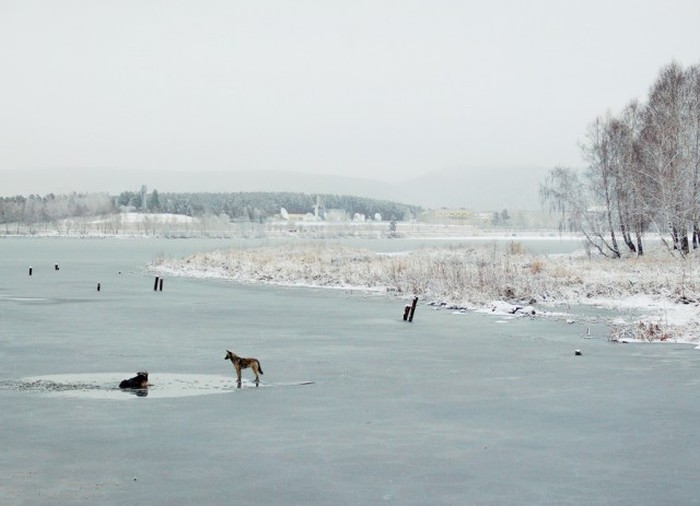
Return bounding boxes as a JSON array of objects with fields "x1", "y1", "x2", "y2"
[{"x1": 0, "y1": 239, "x2": 700, "y2": 506}]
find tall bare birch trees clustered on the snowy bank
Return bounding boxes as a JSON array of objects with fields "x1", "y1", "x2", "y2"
[{"x1": 540, "y1": 62, "x2": 700, "y2": 258}]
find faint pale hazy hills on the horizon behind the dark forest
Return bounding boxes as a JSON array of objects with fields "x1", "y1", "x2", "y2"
[{"x1": 0, "y1": 167, "x2": 548, "y2": 211}]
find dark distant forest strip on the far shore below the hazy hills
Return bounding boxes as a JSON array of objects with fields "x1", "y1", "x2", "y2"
[{"x1": 0, "y1": 190, "x2": 423, "y2": 225}]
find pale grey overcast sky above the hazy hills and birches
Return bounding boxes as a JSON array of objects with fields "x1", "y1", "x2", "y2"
[{"x1": 0, "y1": 0, "x2": 700, "y2": 180}]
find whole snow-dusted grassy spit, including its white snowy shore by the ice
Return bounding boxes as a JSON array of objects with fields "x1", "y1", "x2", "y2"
[{"x1": 150, "y1": 243, "x2": 700, "y2": 348}]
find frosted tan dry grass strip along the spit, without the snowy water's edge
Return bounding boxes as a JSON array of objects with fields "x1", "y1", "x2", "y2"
[{"x1": 155, "y1": 242, "x2": 700, "y2": 307}]
